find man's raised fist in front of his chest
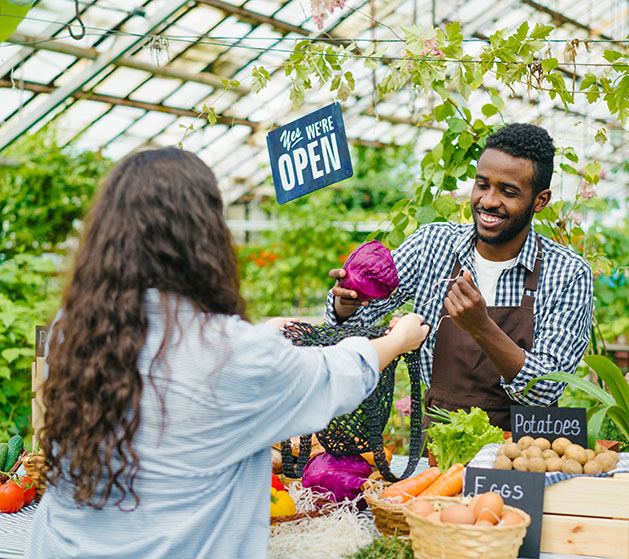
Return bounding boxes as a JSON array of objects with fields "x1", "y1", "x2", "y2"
[{"x1": 444, "y1": 270, "x2": 491, "y2": 334}]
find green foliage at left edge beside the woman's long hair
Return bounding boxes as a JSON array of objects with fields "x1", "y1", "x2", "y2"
[{"x1": 0, "y1": 130, "x2": 110, "y2": 444}]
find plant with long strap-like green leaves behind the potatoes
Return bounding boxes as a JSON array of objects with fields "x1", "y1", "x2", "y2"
[{"x1": 524, "y1": 355, "x2": 629, "y2": 448}]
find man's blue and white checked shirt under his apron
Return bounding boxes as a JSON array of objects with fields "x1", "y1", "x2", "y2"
[{"x1": 325, "y1": 223, "x2": 593, "y2": 406}]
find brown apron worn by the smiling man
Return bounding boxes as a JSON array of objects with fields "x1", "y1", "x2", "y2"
[{"x1": 423, "y1": 239, "x2": 542, "y2": 431}]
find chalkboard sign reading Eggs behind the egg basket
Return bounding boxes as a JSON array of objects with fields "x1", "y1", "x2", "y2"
[{"x1": 464, "y1": 467, "x2": 544, "y2": 559}]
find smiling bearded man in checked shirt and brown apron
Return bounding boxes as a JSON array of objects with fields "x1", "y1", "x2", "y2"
[{"x1": 326, "y1": 123, "x2": 593, "y2": 430}]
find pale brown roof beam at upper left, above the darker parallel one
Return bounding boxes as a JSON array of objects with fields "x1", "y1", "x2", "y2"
[{"x1": 7, "y1": 33, "x2": 250, "y2": 94}]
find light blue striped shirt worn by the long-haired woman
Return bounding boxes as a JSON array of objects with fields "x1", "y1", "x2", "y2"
[{"x1": 25, "y1": 290, "x2": 378, "y2": 559}]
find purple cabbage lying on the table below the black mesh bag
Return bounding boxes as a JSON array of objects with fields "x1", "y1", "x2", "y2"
[{"x1": 301, "y1": 452, "x2": 371, "y2": 503}]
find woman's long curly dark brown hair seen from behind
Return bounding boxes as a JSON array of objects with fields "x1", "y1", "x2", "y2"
[{"x1": 41, "y1": 148, "x2": 246, "y2": 509}]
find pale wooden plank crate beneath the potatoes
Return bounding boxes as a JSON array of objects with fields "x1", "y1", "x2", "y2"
[{"x1": 541, "y1": 474, "x2": 629, "y2": 559}]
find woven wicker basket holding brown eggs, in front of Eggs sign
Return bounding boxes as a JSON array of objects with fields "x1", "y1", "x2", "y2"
[{"x1": 403, "y1": 497, "x2": 531, "y2": 559}]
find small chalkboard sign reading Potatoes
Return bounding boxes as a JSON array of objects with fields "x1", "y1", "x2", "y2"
[{"x1": 511, "y1": 406, "x2": 588, "y2": 448}]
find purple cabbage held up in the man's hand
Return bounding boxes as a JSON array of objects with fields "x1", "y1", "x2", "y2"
[{"x1": 341, "y1": 240, "x2": 400, "y2": 301}]
